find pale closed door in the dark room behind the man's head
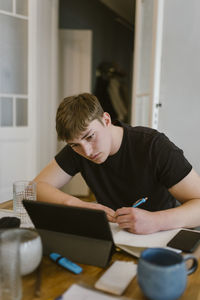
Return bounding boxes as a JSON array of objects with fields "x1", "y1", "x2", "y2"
[{"x1": 59, "y1": 29, "x2": 92, "y2": 196}]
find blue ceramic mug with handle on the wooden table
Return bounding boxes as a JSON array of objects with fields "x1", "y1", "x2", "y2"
[{"x1": 137, "y1": 248, "x2": 198, "y2": 300}]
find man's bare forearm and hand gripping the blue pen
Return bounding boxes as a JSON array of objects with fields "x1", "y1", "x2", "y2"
[{"x1": 115, "y1": 199, "x2": 200, "y2": 234}]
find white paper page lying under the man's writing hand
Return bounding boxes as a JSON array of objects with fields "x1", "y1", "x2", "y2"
[{"x1": 110, "y1": 223, "x2": 180, "y2": 248}]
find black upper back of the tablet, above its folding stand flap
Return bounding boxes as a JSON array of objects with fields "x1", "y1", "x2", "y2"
[{"x1": 23, "y1": 200, "x2": 112, "y2": 241}]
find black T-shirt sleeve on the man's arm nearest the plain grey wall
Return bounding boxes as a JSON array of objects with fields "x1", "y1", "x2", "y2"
[{"x1": 151, "y1": 133, "x2": 192, "y2": 188}]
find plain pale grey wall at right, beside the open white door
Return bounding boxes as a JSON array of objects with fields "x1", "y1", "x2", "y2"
[{"x1": 158, "y1": 0, "x2": 200, "y2": 174}]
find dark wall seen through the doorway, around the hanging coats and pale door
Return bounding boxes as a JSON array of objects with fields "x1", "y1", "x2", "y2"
[{"x1": 59, "y1": 0, "x2": 134, "y2": 122}]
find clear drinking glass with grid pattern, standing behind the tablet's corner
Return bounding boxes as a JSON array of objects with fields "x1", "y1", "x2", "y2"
[{"x1": 13, "y1": 180, "x2": 37, "y2": 227}]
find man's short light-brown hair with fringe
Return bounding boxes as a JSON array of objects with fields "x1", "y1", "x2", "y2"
[{"x1": 56, "y1": 93, "x2": 104, "y2": 141}]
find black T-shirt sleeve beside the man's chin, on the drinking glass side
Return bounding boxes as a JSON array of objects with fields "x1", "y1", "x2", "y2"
[{"x1": 55, "y1": 145, "x2": 80, "y2": 176}]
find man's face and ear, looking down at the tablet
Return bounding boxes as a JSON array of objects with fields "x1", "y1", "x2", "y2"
[{"x1": 67, "y1": 113, "x2": 112, "y2": 164}]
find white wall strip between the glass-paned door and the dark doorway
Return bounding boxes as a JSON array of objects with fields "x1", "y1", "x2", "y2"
[{"x1": 31, "y1": 0, "x2": 59, "y2": 173}]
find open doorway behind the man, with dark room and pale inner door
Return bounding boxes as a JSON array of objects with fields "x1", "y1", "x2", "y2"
[{"x1": 59, "y1": 0, "x2": 135, "y2": 196}]
